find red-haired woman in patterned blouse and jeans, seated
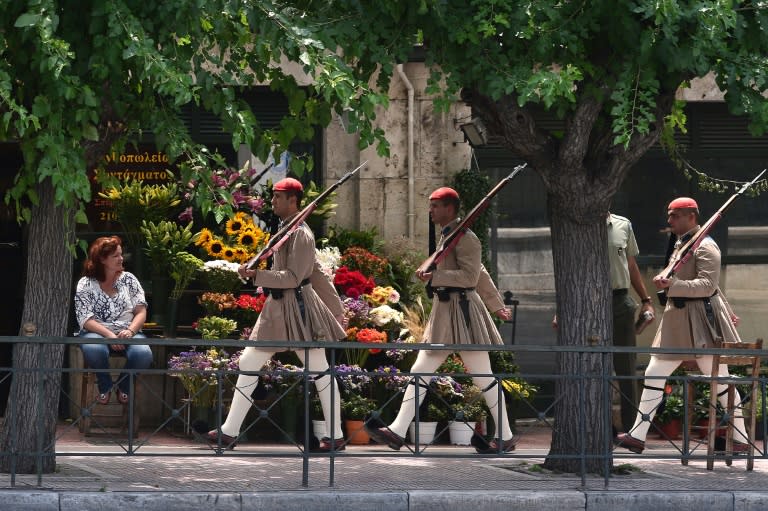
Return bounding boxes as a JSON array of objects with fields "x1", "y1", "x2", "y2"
[{"x1": 75, "y1": 236, "x2": 152, "y2": 404}]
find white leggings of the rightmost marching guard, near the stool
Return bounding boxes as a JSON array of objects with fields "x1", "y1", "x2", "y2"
[{"x1": 629, "y1": 355, "x2": 747, "y2": 443}]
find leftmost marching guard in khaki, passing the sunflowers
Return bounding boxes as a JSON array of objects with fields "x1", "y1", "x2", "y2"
[{"x1": 207, "y1": 178, "x2": 345, "y2": 451}]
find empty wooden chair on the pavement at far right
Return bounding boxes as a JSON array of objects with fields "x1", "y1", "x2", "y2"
[{"x1": 682, "y1": 339, "x2": 763, "y2": 470}]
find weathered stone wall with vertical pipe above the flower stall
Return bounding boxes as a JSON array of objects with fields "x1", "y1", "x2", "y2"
[{"x1": 323, "y1": 63, "x2": 470, "y2": 246}]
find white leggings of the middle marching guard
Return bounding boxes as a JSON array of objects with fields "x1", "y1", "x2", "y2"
[{"x1": 389, "y1": 350, "x2": 512, "y2": 440}]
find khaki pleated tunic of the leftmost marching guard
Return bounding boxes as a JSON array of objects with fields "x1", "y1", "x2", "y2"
[{"x1": 250, "y1": 216, "x2": 345, "y2": 341}]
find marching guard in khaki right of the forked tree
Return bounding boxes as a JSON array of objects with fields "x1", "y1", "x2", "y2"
[{"x1": 615, "y1": 197, "x2": 749, "y2": 454}]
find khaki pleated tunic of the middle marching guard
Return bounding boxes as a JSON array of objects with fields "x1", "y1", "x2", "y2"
[{"x1": 424, "y1": 222, "x2": 504, "y2": 344}]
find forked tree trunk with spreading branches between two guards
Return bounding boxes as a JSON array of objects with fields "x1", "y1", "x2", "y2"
[{"x1": 461, "y1": 85, "x2": 679, "y2": 473}]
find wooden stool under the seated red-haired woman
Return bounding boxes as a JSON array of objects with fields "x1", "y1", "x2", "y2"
[{"x1": 79, "y1": 353, "x2": 140, "y2": 437}]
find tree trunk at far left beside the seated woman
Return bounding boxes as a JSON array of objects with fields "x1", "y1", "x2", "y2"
[{"x1": 0, "y1": 178, "x2": 75, "y2": 474}]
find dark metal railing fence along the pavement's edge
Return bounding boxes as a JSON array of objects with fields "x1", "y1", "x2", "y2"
[{"x1": 0, "y1": 336, "x2": 768, "y2": 487}]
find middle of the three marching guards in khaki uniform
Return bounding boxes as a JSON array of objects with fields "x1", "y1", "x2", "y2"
[{"x1": 366, "y1": 188, "x2": 516, "y2": 453}]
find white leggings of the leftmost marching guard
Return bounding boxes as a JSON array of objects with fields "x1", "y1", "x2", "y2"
[{"x1": 221, "y1": 346, "x2": 344, "y2": 438}]
